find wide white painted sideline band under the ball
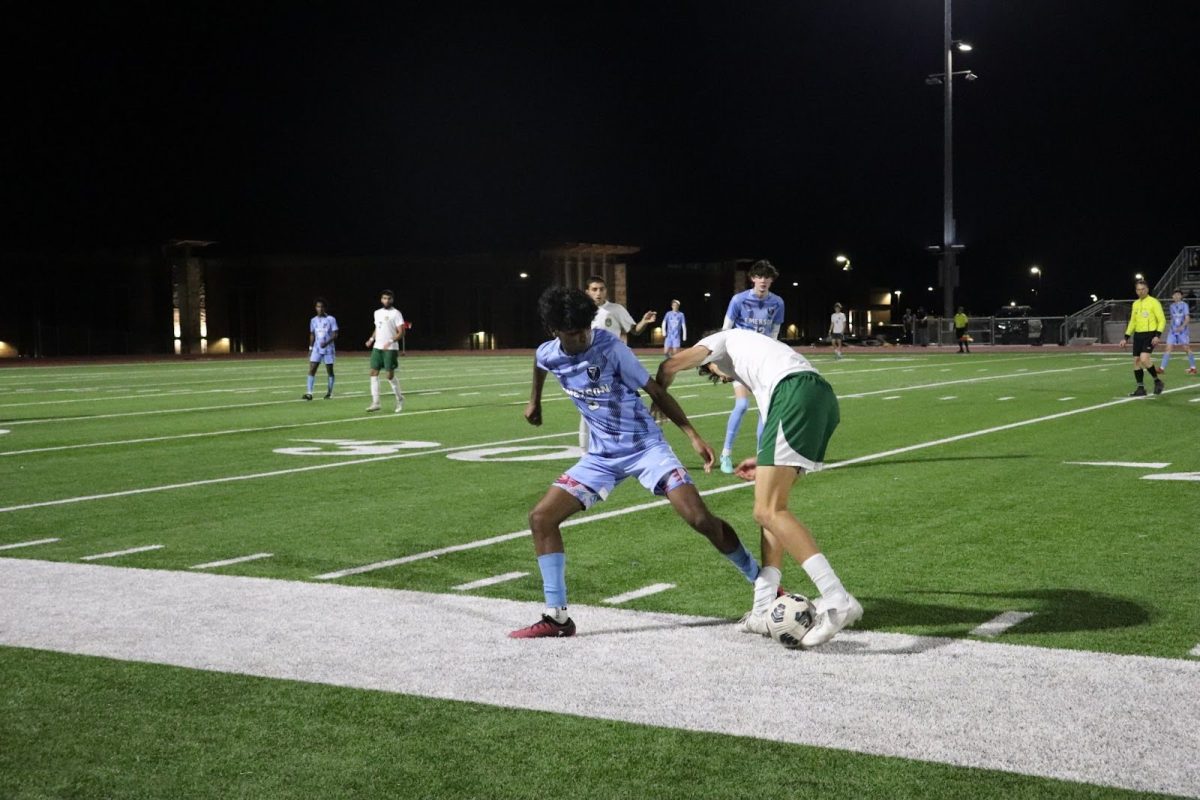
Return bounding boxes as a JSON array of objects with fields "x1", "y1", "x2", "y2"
[{"x1": 0, "y1": 559, "x2": 1200, "y2": 796}]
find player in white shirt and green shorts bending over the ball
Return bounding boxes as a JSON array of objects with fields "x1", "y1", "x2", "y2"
[{"x1": 656, "y1": 330, "x2": 863, "y2": 648}]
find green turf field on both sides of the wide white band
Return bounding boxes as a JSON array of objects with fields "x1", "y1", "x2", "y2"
[{"x1": 0, "y1": 349, "x2": 1200, "y2": 798}]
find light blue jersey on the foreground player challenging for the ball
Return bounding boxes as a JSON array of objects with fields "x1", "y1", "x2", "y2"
[{"x1": 535, "y1": 329, "x2": 662, "y2": 456}]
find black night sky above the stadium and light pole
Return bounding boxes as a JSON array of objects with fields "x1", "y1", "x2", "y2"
[{"x1": 0, "y1": 0, "x2": 1200, "y2": 311}]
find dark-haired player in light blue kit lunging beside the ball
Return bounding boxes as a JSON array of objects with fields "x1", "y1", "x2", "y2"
[{"x1": 509, "y1": 287, "x2": 758, "y2": 639}]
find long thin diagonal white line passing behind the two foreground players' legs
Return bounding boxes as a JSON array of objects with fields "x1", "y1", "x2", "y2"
[{"x1": 316, "y1": 385, "x2": 1195, "y2": 581}]
